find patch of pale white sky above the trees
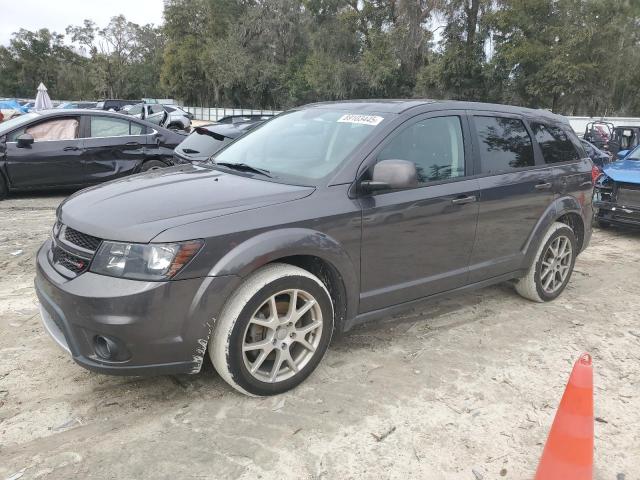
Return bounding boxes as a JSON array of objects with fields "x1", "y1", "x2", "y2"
[{"x1": 0, "y1": 0, "x2": 163, "y2": 45}]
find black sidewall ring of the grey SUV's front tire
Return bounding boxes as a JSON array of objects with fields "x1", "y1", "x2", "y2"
[{"x1": 227, "y1": 275, "x2": 333, "y2": 396}]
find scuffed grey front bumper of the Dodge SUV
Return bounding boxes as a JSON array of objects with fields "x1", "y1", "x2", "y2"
[{"x1": 35, "y1": 240, "x2": 238, "y2": 375}]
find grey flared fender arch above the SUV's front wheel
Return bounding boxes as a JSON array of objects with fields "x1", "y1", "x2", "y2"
[{"x1": 209, "y1": 228, "x2": 359, "y2": 331}]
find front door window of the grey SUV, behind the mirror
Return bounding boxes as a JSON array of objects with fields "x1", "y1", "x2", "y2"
[{"x1": 378, "y1": 117, "x2": 464, "y2": 183}]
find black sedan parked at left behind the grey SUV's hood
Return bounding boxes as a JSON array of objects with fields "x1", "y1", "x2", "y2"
[{"x1": 0, "y1": 109, "x2": 184, "y2": 198}]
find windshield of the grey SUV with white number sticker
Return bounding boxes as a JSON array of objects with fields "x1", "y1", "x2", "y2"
[{"x1": 213, "y1": 108, "x2": 384, "y2": 184}]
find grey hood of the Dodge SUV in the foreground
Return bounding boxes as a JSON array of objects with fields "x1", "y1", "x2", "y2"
[{"x1": 58, "y1": 165, "x2": 314, "y2": 243}]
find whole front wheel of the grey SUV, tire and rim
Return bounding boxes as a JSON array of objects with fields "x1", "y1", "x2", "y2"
[{"x1": 208, "y1": 263, "x2": 334, "y2": 396}]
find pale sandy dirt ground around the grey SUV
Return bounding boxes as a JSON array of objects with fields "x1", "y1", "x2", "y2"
[{"x1": 0, "y1": 196, "x2": 640, "y2": 480}]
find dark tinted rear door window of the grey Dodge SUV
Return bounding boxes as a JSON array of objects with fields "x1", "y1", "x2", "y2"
[{"x1": 474, "y1": 117, "x2": 535, "y2": 173}]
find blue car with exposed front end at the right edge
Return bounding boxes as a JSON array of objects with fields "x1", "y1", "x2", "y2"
[{"x1": 593, "y1": 147, "x2": 640, "y2": 228}]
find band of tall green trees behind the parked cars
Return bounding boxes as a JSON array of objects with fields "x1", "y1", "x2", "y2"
[{"x1": 0, "y1": 0, "x2": 640, "y2": 115}]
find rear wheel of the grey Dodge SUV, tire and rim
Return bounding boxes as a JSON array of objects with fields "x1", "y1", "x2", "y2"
[{"x1": 516, "y1": 222, "x2": 578, "y2": 302}]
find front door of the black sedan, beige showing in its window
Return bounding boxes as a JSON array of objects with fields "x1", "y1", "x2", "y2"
[{"x1": 6, "y1": 116, "x2": 85, "y2": 188}]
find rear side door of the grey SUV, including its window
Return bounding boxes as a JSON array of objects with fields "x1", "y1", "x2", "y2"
[{"x1": 469, "y1": 112, "x2": 554, "y2": 283}]
